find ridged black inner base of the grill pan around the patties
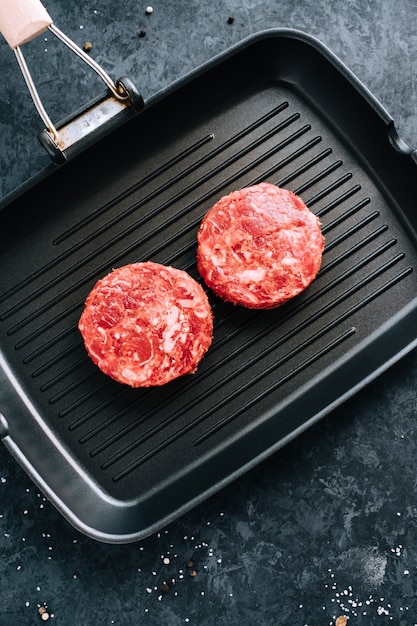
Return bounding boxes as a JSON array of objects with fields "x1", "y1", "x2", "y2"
[{"x1": 0, "y1": 85, "x2": 415, "y2": 495}]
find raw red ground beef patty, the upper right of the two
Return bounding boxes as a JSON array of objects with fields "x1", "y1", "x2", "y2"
[{"x1": 197, "y1": 183, "x2": 324, "y2": 309}]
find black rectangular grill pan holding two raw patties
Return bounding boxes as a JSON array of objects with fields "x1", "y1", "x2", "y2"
[{"x1": 0, "y1": 30, "x2": 417, "y2": 543}]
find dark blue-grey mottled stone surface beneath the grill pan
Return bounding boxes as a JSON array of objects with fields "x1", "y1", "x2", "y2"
[{"x1": 0, "y1": 0, "x2": 417, "y2": 626}]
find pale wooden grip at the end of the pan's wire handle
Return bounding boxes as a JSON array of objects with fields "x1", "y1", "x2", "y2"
[{"x1": 0, "y1": 0, "x2": 52, "y2": 48}]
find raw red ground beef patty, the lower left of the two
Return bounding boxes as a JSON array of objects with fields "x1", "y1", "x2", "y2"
[{"x1": 78, "y1": 262, "x2": 213, "y2": 387}]
